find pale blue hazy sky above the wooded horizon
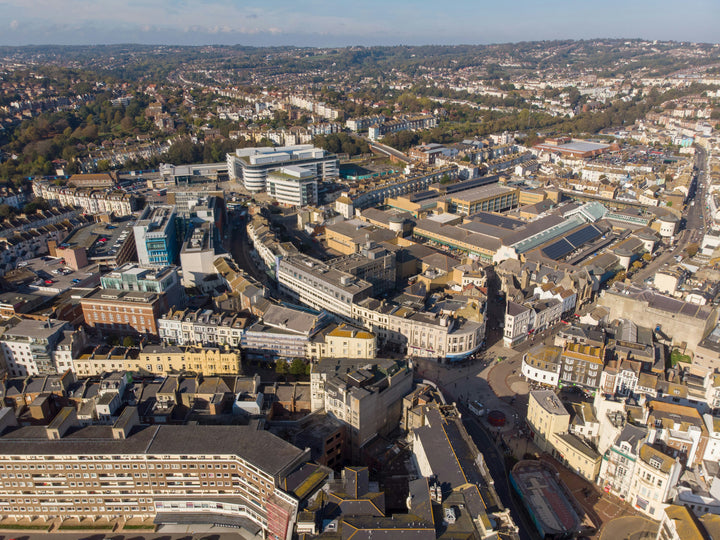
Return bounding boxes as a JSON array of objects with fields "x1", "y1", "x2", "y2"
[{"x1": 0, "y1": 0, "x2": 720, "y2": 47}]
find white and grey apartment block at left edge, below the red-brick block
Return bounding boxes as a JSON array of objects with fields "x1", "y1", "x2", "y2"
[{"x1": 0, "y1": 319, "x2": 70, "y2": 377}]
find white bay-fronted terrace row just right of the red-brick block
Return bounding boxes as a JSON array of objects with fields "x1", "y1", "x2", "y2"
[{"x1": 158, "y1": 309, "x2": 247, "y2": 347}]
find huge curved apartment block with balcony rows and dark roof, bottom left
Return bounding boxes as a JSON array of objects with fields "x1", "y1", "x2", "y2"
[{"x1": 0, "y1": 407, "x2": 309, "y2": 540}]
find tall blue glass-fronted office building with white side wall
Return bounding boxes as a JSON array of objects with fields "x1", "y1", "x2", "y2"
[{"x1": 133, "y1": 206, "x2": 178, "y2": 267}]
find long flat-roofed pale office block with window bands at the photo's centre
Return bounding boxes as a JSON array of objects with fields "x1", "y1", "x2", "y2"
[{"x1": 277, "y1": 255, "x2": 372, "y2": 319}]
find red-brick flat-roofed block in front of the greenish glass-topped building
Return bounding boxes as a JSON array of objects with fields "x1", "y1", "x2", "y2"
[{"x1": 80, "y1": 289, "x2": 168, "y2": 336}]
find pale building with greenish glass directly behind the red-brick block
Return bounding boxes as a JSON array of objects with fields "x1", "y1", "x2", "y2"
[{"x1": 100, "y1": 263, "x2": 185, "y2": 308}]
